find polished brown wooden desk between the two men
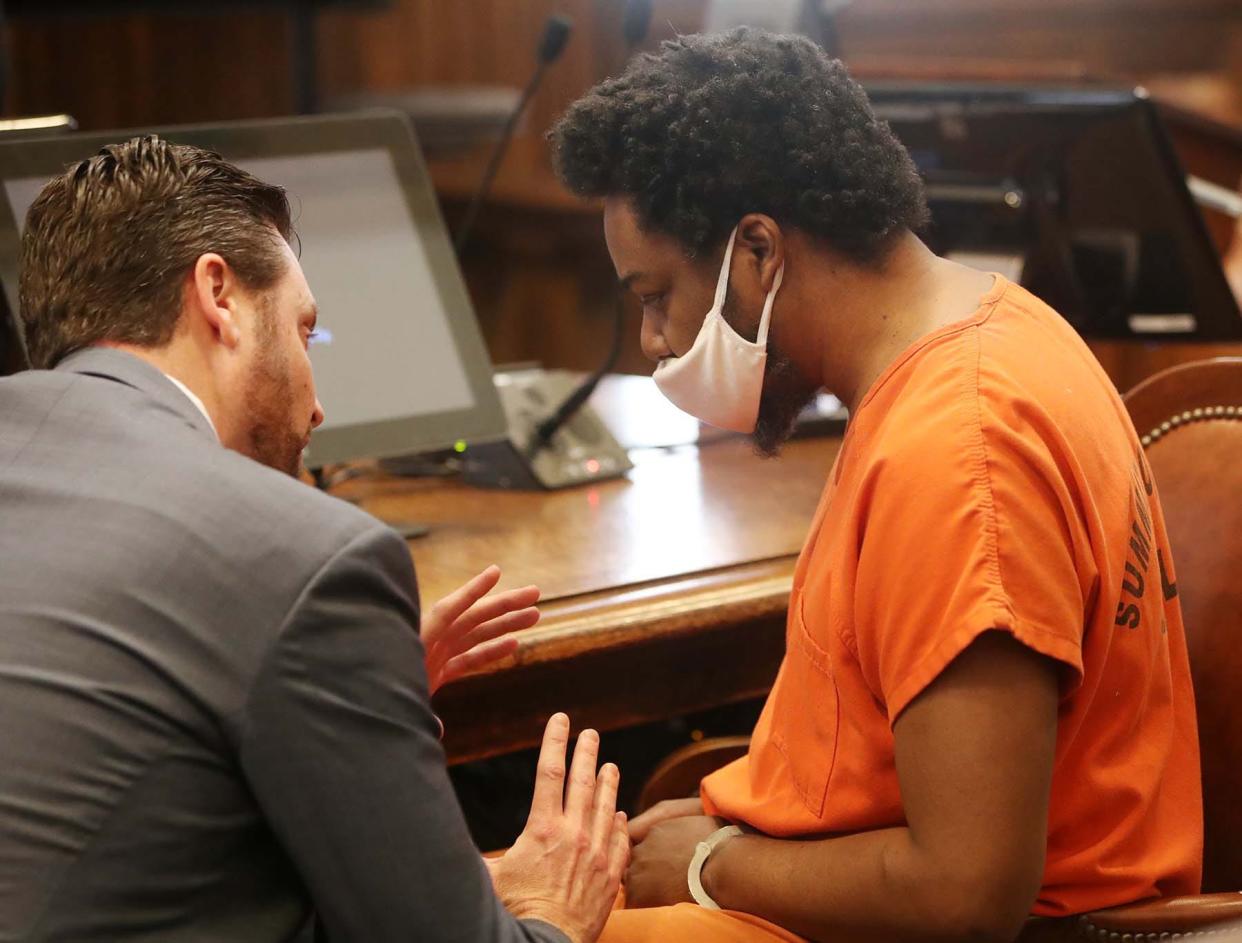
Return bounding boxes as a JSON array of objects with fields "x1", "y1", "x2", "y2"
[{"x1": 338, "y1": 378, "x2": 840, "y2": 762}]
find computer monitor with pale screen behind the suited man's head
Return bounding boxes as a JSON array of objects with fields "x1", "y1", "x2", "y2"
[{"x1": 0, "y1": 112, "x2": 507, "y2": 467}]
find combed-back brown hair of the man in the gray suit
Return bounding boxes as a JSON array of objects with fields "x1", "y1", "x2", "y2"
[{"x1": 19, "y1": 134, "x2": 292, "y2": 368}]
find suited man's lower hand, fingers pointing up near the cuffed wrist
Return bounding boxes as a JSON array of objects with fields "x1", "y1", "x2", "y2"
[{"x1": 487, "y1": 714, "x2": 630, "y2": 943}]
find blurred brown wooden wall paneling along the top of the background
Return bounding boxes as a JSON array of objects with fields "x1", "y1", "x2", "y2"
[{"x1": 12, "y1": 0, "x2": 1242, "y2": 145}]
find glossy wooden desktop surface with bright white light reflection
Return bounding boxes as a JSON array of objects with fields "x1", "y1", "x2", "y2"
[{"x1": 343, "y1": 427, "x2": 835, "y2": 600}]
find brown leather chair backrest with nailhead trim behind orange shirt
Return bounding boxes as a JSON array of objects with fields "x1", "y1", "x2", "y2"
[{"x1": 1125, "y1": 357, "x2": 1242, "y2": 892}]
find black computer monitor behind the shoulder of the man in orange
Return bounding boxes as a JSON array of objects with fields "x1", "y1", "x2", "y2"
[{"x1": 867, "y1": 82, "x2": 1242, "y2": 340}]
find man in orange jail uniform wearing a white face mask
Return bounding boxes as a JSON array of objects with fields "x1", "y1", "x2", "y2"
[{"x1": 553, "y1": 30, "x2": 1202, "y2": 943}]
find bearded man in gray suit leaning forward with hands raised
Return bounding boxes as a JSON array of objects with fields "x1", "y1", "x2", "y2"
[{"x1": 0, "y1": 138, "x2": 628, "y2": 943}]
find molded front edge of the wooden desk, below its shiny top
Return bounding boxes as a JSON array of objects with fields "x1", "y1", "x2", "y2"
[{"x1": 436, "y1": 557, "x2": 796, "y2": 763}]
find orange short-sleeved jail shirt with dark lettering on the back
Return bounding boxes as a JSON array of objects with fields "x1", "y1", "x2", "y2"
[{"x1": 703, "y1": 277, "x2": 1202, "y2": 916}]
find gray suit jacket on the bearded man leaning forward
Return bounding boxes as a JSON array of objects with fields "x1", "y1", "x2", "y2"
[{"x1": 0, "y1": 349, "x2": 564, "y2": 943}]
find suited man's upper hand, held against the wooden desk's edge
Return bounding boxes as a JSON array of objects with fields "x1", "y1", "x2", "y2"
[{"x1": 420, "y1": 565, "x2": 539, "y2": 695}]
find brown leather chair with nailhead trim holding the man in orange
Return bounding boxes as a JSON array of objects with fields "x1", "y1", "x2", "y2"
[{"x1": 641, "y1": 357, "x2": 1242, "y2": 943}]
